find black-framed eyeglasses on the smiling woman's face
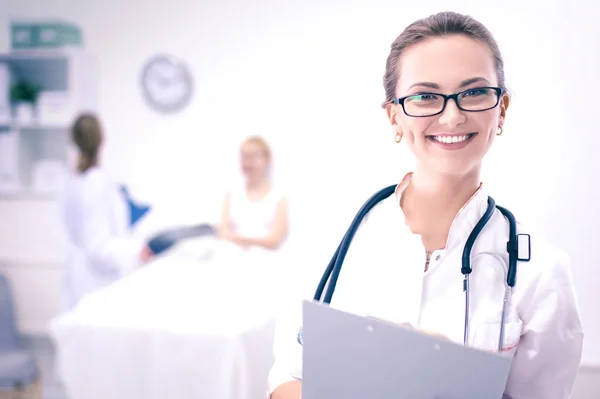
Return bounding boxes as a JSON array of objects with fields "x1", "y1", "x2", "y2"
[{"x1": 381, "y1": 87, "x2": 503, "y2": 118}]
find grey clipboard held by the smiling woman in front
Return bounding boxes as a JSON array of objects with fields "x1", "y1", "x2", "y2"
[{"x1": 302, "y1": 301, "x2": 512, "y2": 399}]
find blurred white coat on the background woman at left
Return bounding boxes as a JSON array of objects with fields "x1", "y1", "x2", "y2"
[{"x1": 62, "y1": 167, "x2": 144, "y2": 311}]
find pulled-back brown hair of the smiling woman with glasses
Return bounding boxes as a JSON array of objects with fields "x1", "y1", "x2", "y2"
[{"x1": 383, "y1": 12, "x2": 506, "y2": 104}]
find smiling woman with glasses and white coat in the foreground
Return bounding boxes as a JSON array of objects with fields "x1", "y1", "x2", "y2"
[{"x1": 269, "y1": 13, "x2": 583, "y2": 399}]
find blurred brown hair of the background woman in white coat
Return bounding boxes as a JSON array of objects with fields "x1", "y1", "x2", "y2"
[{"x1": 71, "y1": 114, "x2": 102, "y2": 173}]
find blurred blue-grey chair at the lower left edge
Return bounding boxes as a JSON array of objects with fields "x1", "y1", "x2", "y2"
[{"x1": 0, "y1": 274, "x2": 39, "y2": 390}]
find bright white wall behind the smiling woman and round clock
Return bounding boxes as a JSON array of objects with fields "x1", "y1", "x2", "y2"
[{"x1": 0, "y1": 0, "x2": 600, "y2": 364}]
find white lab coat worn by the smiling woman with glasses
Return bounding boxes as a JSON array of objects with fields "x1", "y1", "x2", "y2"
[{"x1": 269, "y1": 177, "x2": 583, "y2": 399}]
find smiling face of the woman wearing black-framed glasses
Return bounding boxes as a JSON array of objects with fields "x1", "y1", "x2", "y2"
[{"x1": 383, "y1": 32, "x2": 510, "y2": 180}]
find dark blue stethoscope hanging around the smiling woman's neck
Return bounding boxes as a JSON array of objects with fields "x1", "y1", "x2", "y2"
[{"x1": 297, "y1": 184, "x2": 531, "y2": 352}]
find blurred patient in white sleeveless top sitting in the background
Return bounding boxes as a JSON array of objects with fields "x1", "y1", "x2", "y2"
[{"x1": 218, "y1": 136, "x2": 289, "y2": 250}]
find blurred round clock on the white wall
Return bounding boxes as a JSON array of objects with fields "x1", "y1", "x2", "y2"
[{"x1": 141, "y1": 55, "x2": 194, "y2": 113}]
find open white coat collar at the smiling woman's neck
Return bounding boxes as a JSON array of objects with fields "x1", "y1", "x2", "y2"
[{"x1": 396, "y1": 172, "x2": 488, "y2": 250}]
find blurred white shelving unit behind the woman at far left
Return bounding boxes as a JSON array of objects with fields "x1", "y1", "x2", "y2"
[{"x1": 0, "y1": 47, "x2": 97, "y2": 198}]
